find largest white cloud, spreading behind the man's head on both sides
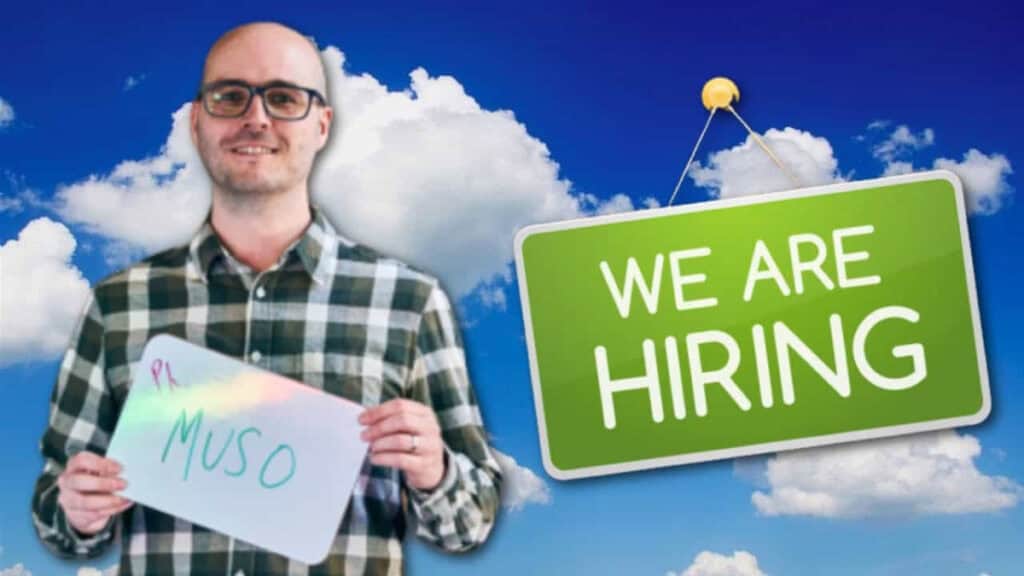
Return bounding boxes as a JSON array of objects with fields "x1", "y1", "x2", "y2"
[{"x1": 56, "y1": 47, "x2": 630, "y2": 295}]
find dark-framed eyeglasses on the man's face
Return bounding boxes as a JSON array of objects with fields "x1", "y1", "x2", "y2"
[{"x1": 196, "y1": 80, "x2": 327, "y2": 121}]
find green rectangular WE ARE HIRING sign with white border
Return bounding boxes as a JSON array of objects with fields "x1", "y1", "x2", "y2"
[{"x1": 516, "y1": 171, "x2": 991, "y2": 480}]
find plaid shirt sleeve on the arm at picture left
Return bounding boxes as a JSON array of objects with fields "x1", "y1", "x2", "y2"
[{"x1": 32, "y1": 296, "x2": 117, "y2": 558}]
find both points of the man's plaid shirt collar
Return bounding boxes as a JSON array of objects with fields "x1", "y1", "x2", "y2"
[{"x1": 187, "y1": 206, "x2": 342, "y2": 284}]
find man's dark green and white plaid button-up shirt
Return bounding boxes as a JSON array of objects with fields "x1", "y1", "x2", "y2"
[{"x1": 32, "y1": 210, "x2": 501, "y2": 576}]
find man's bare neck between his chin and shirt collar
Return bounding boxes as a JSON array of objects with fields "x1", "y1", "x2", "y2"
[{"x1": 210, "y1": 184, "x2": 310, "y2": 272}]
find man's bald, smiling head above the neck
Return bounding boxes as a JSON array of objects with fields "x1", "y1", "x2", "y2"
[{"x1": 191, "y1": 23, "x2": 333, "y2": 200}]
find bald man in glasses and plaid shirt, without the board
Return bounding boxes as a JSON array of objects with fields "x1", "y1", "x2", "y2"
[{"x1": 33, "y1": 24, "x2": 501, "y2": 576}]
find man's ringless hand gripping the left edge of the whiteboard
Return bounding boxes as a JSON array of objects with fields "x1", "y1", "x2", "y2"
[{"x1": 57, "y1": 452, "x2": 134, "y2": 536}]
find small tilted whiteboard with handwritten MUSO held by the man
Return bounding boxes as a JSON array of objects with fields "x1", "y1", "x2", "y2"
[{"x1": 106, "y1": 335, "x2": 368, "y2": 564}]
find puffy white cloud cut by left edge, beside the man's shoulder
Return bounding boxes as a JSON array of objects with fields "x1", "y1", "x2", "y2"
[{"x1": 0, "y1": 217, "x2": 89, "y2": 365}]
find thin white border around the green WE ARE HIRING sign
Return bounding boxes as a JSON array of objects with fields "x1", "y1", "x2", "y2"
[{"x1": 514, "y1": 170, "x2": 992, "y2": 481}]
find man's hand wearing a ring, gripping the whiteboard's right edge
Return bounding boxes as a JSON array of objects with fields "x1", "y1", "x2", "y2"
[{"x1": 359, "y1": 399, "x2": 444, "y2": 492}]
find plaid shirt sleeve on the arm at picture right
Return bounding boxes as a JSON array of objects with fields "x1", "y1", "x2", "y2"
[{"x1": 408, "y1": 285, "x2": 502, "y2": 551}]
